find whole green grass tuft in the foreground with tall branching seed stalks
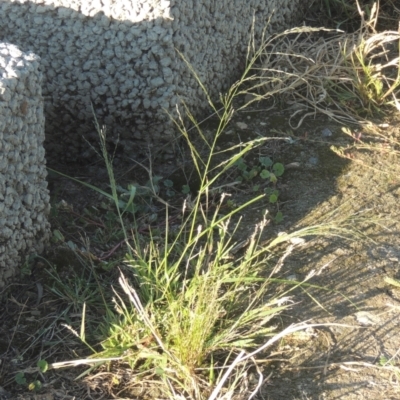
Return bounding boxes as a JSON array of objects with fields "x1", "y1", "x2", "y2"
[{"x1": 46, "y1": 21, "x2": 368, "y2": 400}]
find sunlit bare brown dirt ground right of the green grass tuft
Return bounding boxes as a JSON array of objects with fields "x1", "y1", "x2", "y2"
[{"x1": 225, "y1": 101, "x2": 400, "y2": 400}]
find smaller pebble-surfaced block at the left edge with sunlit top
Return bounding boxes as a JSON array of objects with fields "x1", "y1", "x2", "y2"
[{"x1": 0, "y1": 43, "x2": 50, "y2": 287}]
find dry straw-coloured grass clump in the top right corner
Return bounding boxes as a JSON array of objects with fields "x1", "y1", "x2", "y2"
[{"x1": 255, "y1": 2, "x2": 400, "y2": 129}]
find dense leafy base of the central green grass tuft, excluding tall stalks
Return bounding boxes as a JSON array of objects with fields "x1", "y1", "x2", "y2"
[{"x1": 96, "y1": 211, "x2": 360, "y2": 399}]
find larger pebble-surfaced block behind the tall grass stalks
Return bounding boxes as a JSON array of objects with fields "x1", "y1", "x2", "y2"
[{"x1": 0, "y1": 0, "x2": 310, "y2": 160}]
